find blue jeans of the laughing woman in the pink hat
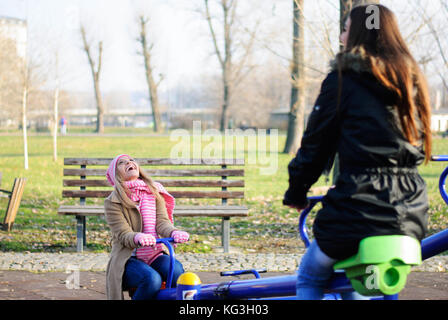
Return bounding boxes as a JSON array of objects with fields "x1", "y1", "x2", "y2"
[{"x1": 123, "y1": 254, "x2": 184, "y2": 300}]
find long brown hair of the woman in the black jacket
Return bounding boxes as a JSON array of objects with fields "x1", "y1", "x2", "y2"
[{"x1": 344, "y1": 5, "x2": 432, "y2": 163}]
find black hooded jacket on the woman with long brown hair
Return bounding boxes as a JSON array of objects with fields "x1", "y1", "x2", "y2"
[{"x1": 283, "y1": 50, "x2": 428, "y2": 259}]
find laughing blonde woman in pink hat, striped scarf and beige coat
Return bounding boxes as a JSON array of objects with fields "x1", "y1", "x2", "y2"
[{"x1": 104, "y1": 154, "x2": 189, "y2": 300}]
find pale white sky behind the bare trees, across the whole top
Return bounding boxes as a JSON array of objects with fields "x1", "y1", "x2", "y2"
[{"x1": 0, "y1": 0, "x2": 442, "y2": 95}]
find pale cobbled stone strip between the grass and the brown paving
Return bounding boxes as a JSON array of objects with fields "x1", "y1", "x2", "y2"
[{"x1": 0, "y1": 252, "x2": 448, "y2": 272}]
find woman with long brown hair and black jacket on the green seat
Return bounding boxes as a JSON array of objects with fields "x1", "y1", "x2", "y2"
[{"x1": 283, "y1": 5, "x2": 431, "y2": 299}]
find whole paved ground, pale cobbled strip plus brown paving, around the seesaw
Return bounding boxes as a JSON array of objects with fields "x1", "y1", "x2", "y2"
[{"x1": 0, "y1": 252, "x2": 448, "y2": 300}]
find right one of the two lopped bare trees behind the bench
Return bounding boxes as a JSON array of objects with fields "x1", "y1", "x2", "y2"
[{"x1": 138, "y1": 15, "x2": 163, "y2": 132}]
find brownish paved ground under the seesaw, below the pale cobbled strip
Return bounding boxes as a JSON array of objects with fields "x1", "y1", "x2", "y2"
[{"x1": 0, "y1": 271, "x2": 448, "y2": 300}]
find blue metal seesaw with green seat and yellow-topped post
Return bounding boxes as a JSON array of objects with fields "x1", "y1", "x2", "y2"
[{"x1": 152, "y1": 156, "x2": 448, "y2": 300}]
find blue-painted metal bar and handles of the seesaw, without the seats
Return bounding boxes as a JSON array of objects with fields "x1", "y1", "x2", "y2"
[{"x1": 157, "y1": 156, "x2": 448, "y2": 300}]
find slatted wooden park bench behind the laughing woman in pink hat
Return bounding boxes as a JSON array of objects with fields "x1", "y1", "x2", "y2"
[{"x1": 58, "y1": 158, "x2": 248, "y2": 252}]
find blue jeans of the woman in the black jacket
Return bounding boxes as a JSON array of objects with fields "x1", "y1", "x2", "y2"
[{"x1": 296, "y1": 241, "x2": 369, "y2": 300}]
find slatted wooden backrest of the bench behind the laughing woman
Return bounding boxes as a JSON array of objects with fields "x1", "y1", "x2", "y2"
[{"x1": 62, "y1": 158, "x2": 244, "y2": 204}]
